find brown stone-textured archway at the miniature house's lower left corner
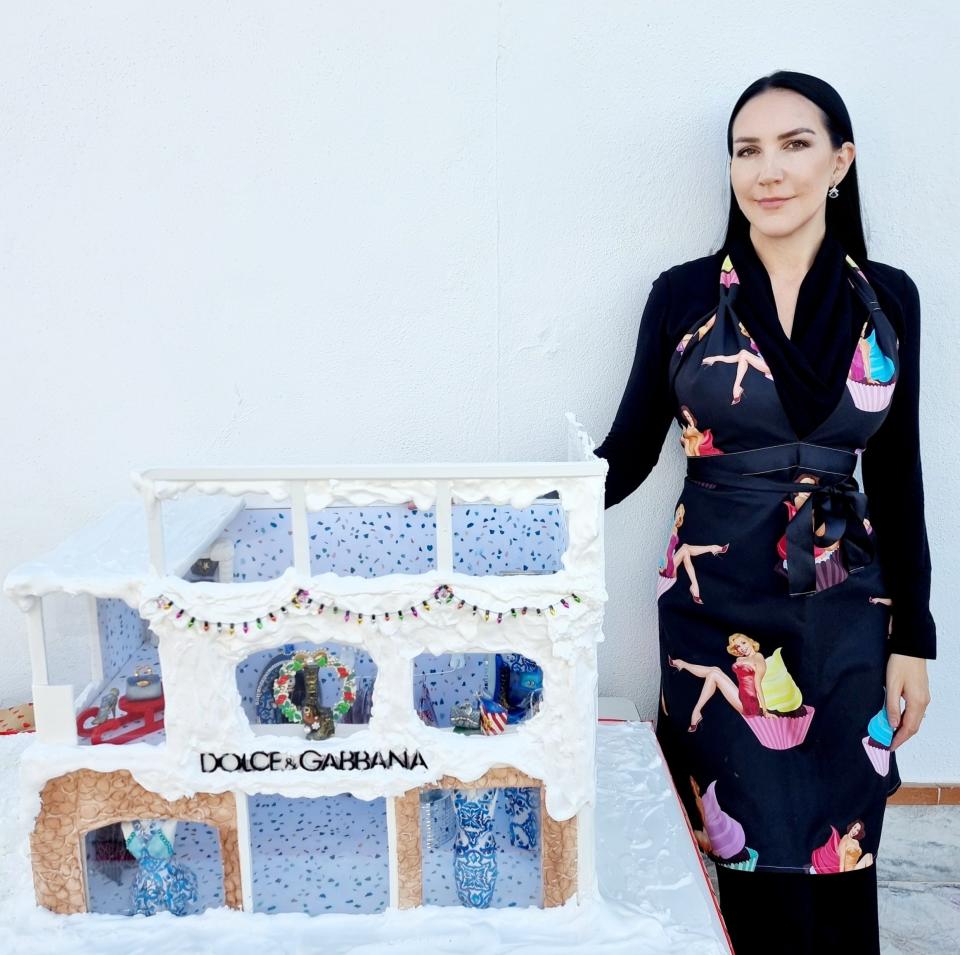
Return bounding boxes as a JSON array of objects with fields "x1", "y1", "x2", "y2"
[{"x1": 30, "y1": 769, "x2": 242, "y2": 915}]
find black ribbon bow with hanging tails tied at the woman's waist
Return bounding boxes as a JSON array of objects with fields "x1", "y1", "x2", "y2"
[{"x1": 787, "y1": 478, "x2": 875, "y2": 597}]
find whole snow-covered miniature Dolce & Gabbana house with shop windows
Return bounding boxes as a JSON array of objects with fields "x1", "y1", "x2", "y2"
[{"x1": 5, "y1": 414, "x2": 607, "y2": 915}]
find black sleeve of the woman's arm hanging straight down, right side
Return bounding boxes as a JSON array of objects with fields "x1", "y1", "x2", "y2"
[{"x1": 861, "y1": 272, "x2": 937, "y2": 660}]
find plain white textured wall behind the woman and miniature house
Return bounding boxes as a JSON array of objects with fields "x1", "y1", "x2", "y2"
[{"x1": 0, "y1": 0, "x2": 960, "y2": 781}]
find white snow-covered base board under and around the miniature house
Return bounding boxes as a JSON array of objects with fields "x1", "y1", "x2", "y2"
[{"x1": 0, "y1": 723, "x2": 729, "y2": 955}]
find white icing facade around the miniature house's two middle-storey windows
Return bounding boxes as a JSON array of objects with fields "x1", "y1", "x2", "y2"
[{"x1": 20, "y1": 570, "x2": 606, "y2": 819}]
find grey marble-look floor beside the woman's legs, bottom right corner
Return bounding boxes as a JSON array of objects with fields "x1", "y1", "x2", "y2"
[{"x1": 707, "y1": 806, "x2": 960, "y2": 955}]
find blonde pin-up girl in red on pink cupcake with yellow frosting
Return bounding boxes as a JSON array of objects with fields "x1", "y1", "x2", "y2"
[{"x1": 667, "y1": 633, "x2": 814, "y2": 749}]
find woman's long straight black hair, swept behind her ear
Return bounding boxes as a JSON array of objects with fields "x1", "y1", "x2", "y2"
[{"x1": 723, "y1": 70, "x2": 867, "y2": 266}]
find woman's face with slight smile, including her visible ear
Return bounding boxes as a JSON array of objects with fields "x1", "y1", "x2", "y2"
[{"x1": 730, "y1": 90, "x2": 856, "y2": 238}]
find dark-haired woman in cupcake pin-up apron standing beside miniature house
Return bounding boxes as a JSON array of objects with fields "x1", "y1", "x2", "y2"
[{"x1": 596, "y1": 72, "x2": 936, "y2": 955}]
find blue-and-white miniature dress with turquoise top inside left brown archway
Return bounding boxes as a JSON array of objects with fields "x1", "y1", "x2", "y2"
[{"x1": 121, "y1": 819, "x2": 198, "y2": 915}]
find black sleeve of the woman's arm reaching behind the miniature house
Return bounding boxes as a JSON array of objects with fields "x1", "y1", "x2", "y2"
[{"x1": 594, "y1": 272, "x2": 671, "y2": 508}]
